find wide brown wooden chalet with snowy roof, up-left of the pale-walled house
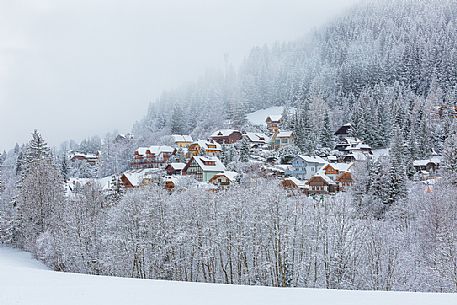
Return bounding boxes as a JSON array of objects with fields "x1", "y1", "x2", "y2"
[{"x1": 130, "y1": 145, "x2": 176, "y2": 169}]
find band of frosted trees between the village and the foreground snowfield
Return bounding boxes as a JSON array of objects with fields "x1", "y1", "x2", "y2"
[{"x1": 0, "y1": 132, "x2": 457, "y2": 292}]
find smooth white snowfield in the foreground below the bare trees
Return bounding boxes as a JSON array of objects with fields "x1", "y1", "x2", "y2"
[{"x1": 0, "y1": 247, "x2": 457, "y2": 305}]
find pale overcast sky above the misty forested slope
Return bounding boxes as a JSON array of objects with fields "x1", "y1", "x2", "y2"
[{"x1": 0, "y1": 0, "x2": 355, "y2": 150}]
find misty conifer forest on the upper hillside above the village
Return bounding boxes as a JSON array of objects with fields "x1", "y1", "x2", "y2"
[{"x1": 135, "y1": 0, "x2": 457, "y2": 147}]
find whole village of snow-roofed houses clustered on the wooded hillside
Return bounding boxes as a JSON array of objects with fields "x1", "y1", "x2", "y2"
[{"x1": 66, "y1": 115, "x2": 442, "y2": 195}]
